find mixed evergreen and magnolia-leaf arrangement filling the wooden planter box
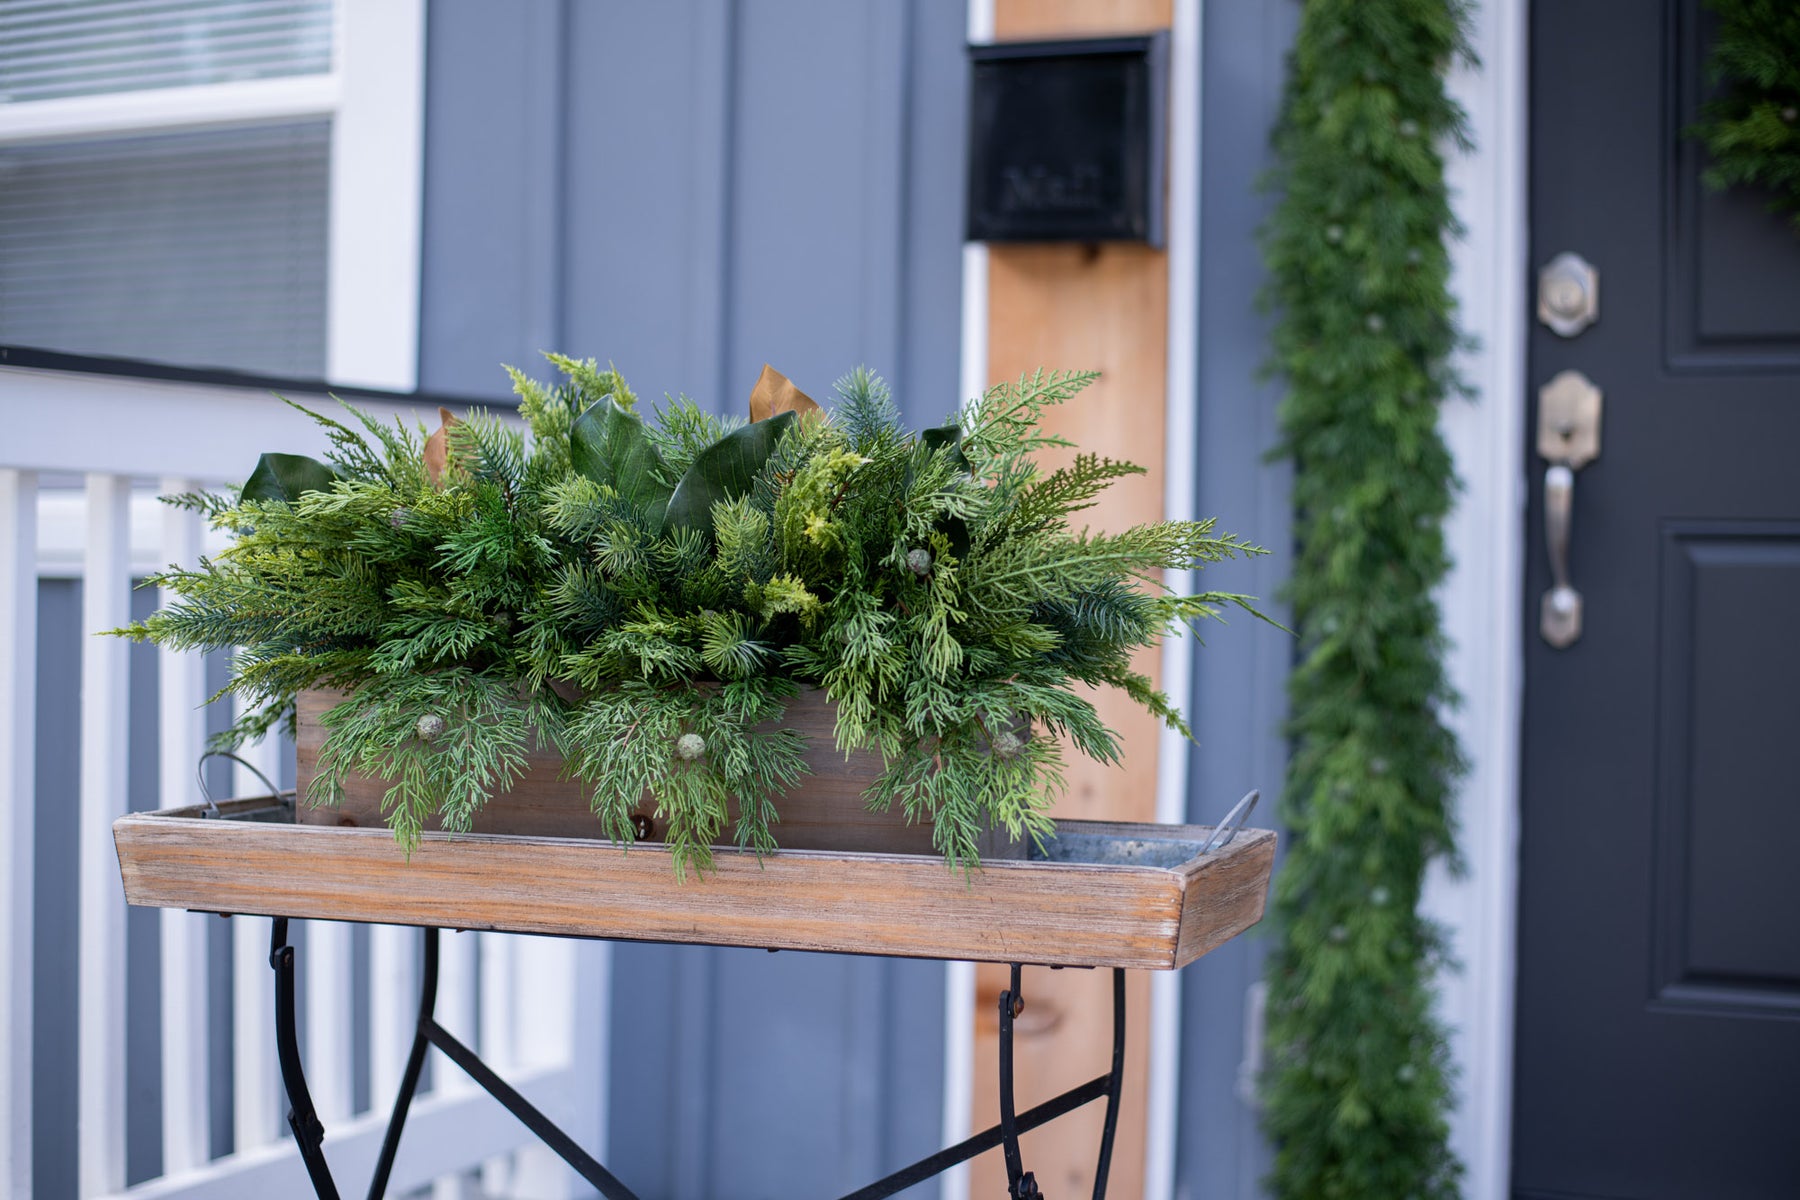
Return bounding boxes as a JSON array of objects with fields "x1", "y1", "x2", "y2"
[{"x1": 122, "y1": 356, "x2": 1255, "y2": 871}]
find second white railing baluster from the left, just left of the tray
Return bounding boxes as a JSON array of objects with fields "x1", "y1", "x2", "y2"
[{"x1": 76, "y1": 473, "x2": 131, "y2": 1196}]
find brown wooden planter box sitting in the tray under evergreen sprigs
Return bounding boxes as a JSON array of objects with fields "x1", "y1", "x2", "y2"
[{"x1": 295, "y1": 687, "x2": 1028, "y2": 860}]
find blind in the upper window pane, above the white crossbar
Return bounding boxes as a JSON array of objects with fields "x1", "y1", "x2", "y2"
[{"x1": 0, "y1": 0, "x2": 333, "y2": 104}]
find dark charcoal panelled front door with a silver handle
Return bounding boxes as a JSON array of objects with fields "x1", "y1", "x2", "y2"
[{"x1": 1514, "y1": 0, "x2": 1800, "y2": 1200}]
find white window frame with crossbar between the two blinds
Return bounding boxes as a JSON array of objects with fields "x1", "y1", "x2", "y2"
[{"x1": 0, "y1": 0, "x2": 425, "y2": 392}]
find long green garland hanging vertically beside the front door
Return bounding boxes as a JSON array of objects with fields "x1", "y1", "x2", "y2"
[{"x1": 1264, "y1": 0, "x2": 1471, "y2": 1200}]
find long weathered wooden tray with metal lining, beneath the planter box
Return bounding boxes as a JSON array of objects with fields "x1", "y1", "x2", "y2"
[{"x1": 113, "y1": 799, "x2": 1274, "y2": 970}]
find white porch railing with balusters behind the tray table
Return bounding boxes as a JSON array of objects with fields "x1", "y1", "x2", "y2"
[{"x1": 0, "y1": 367, "x2": 607, "y2": 1200}]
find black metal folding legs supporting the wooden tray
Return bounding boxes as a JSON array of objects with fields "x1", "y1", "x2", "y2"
[{"x1": 268, "y1": 918, "x2": 1125, "y2": 1200}]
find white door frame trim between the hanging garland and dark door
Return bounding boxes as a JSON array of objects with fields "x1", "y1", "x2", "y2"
[{"x1": 1420, "y1": 0, "x2": 1528, "y2": 1200}]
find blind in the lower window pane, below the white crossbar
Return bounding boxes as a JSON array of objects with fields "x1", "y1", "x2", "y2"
[{"x1": 0, "y1": 121, "x2": 331, "y2": 378}]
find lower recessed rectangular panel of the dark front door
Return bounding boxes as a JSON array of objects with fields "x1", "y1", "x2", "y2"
[{"x1": 1652, "y1": 522, "x2": 1800, "y2": 1014}]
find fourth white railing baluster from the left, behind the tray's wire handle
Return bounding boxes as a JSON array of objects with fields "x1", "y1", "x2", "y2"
[{"x1": 230, "y1": 732, "x2": 286, "y2": 1153}]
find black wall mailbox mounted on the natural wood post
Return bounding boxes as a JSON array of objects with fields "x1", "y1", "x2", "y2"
[{"x1": 968, "y1": 32, "x2": 1168, "y2": 246}]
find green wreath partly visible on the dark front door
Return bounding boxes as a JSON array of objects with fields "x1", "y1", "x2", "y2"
[{"x1": 1690, "y1": 0, "x2": 1800, "y2": 232}]
